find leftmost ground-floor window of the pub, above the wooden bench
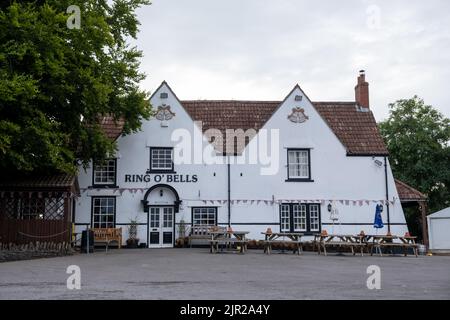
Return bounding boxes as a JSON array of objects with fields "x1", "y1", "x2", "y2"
[{"x1": 92, "y1": 197, "x2": 116, "y2": 228}]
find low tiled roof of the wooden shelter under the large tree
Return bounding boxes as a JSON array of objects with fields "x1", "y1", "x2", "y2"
[{"x1": 0, "y1": 173, "x2": 78, "y2": 190}]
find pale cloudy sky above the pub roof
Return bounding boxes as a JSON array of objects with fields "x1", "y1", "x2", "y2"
[{"x1": 137, "y1": 0, "x2": 450, "y2": 120}]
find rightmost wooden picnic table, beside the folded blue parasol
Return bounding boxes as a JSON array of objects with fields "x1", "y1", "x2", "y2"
[{"x1": 366, "y1": 235, "x2": 418, "y2": 257}]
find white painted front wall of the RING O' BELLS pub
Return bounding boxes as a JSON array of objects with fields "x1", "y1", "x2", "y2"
[{"x1": 76, "y1": 84, "x2": 407, "y2": 242}]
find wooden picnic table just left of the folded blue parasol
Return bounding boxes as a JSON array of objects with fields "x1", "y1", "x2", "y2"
[{"x1": 314, "y1": 234, "x2": 367, "y2": 256}]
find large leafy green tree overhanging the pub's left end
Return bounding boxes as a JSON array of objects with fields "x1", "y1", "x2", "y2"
[{"x1": 0, "y1": 0, "x2": 151, "y2": 173}]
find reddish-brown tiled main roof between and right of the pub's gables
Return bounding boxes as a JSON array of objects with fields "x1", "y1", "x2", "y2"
[{"x1": 181, "y1": 100, "x2": 388, "y2": 155}]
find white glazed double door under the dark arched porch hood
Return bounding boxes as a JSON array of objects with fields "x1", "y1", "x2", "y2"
[{"x1": 149, "y1": 207, "x2": 174, "y2": 248}]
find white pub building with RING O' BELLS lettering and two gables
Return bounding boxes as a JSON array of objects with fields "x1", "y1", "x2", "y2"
[{"x1": 74, "y1": 72, "x2": 408, "y2": 248}]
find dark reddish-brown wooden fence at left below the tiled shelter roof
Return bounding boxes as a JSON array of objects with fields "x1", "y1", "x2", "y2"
[{"x1": 0, "y1": 219, "x2": 72, "y2": 244}]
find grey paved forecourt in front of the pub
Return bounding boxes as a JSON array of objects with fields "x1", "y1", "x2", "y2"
[{"x1": 0, "y1": 248, "x2": 450, "y2": 299}]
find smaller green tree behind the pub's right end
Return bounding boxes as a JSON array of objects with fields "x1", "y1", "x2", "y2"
[{"x1": 379, "y1": 96, "x2": 450, "y2": 218}]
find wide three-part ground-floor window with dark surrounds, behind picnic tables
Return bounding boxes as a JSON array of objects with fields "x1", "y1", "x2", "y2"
[{"x1": 280, "y1": 203, "x2": 321, "y2": 233}]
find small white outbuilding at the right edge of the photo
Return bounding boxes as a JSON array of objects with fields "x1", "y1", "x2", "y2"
[{"x1": 427, "y1": 207, "x2": 450, "y2": 252}]
